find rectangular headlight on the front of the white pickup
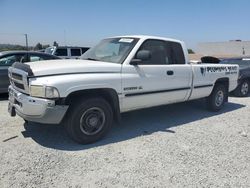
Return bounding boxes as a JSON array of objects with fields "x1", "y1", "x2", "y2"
[{"x1": 30, "y1": 85, "x2": 60, "y2": 98}]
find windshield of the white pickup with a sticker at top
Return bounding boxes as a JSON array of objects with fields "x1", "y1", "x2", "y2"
[{"x1": 80, "y1": 38, "x2": 138, "y2": 64}]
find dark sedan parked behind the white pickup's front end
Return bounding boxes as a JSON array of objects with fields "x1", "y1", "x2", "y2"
[{"x1": 0, "y1": 51, "x2": 61, "y2": 93}]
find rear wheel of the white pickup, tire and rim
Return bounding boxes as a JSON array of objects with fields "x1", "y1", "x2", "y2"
[{"x1": 207, "y1": 84, "x2": 228, "y2": 112}]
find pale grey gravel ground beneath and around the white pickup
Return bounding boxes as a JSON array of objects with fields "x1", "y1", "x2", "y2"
[{"x1": 0, "y1": 94, "x2": 250, "y2": 188}]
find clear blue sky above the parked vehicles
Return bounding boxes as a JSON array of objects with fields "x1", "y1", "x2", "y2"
[{"x1": 0, "y1": 0, "x2": 250, "y2": 49}]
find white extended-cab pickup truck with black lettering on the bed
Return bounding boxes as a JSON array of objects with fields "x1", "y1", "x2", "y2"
[{"x1": 9, "y1": 36, "x2": 239, "y2": 144}]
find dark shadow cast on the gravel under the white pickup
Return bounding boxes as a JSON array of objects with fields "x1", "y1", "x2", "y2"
[{"x1": 23, "y1": 100, "x2": 244, "y2": 151}]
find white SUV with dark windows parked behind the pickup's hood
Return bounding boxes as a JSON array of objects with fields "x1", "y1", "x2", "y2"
[{"x1": 45, "y1": 46, "x2": 89, "y2": 59}]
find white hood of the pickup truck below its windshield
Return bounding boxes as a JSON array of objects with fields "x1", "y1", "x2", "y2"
[{"x1": 26, "y1": 59, "x2": 121, "y2": 77}]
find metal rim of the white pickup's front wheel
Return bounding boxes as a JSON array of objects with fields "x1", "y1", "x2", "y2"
[{"x1": 80, "y1": 107, "x2": 106, "y2": 135}]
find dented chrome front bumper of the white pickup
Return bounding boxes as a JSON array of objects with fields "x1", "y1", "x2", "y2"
[{"x1": 8, "y1": 86, "x2": 69, "y2": 124}]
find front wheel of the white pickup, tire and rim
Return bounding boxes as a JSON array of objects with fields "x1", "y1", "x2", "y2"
[{"x1": 65, "y1": 98, "x2": 113, "y2": 144}]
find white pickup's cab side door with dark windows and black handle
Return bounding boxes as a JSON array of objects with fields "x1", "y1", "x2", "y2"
[{"x1": 122, "y1": 39, "x2": 192, "y2": 111}]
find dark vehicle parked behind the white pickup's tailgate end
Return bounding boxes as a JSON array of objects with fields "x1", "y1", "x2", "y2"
[{"x1": 201, "y1": 56, "x2": 250, "y2": 97}]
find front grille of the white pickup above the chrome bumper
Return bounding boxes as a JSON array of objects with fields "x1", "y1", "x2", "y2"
[{"x1": 9, "y1": 67, "x2": 29, "y2": 94}]
